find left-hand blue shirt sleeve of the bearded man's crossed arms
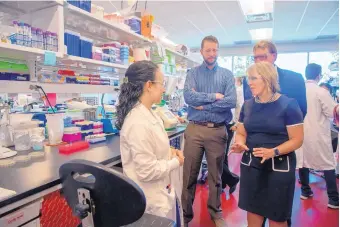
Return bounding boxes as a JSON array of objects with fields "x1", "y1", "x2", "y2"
[{"x1": 184, "y1": 69, "x2": 216, "y2": 107}]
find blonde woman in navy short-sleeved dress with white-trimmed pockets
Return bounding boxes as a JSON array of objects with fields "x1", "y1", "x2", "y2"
[{"x1": 228, "y1": 62, "x2": 303, "y2": 227}]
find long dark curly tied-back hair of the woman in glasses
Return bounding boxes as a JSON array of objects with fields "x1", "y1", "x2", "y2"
[{"x1": 116, "y1": 61, "x2": 158, "y2": 130}]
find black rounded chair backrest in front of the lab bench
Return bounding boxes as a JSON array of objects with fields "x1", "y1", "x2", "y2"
[{"x1": 59, "y1": 160, "x2": 146, "y2": 227}]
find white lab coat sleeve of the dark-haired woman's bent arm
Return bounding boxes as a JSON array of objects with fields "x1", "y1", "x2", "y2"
[{"x1": 129, "y1": 124, "x2": 179, "y2": 182}]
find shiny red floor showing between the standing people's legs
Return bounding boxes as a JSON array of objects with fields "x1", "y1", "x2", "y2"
[{"x1": 189, "y1": 155, "x2": 339, "y2": 227}]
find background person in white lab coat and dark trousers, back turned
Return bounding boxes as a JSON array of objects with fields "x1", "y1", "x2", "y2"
[{"x1": 299, "y1": 64, "x2": 339, "y2": 209}]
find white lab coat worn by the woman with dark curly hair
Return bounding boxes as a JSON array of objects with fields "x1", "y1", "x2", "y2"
[{"x1": 120, "y1": 104, "x2": 180, "y2": 221}]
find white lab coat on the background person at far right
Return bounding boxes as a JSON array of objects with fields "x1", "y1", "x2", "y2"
[{"x1": 296, "y1": 81, "x2": 337, "y2": 170}]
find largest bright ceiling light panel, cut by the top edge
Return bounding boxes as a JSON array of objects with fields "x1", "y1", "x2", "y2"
[{"x1": 238, "y1": 0, "x2": 274, "y2": 15}]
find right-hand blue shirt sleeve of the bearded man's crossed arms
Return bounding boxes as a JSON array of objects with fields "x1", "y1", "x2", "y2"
[{"x1": 203, "y1": 75, "x2": 237, "y2": 112}]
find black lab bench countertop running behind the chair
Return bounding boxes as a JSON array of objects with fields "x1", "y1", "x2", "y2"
[{"x1": 0, "y1": 127, "x2": 185, "y2": 208}]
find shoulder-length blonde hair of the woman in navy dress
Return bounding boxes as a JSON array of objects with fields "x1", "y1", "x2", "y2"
[{"x1": 247, "y1": 61, "x2": 280, "y2": 93}]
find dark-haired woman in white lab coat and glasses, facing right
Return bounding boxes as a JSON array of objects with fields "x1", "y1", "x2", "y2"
[{"x1": 116, "y1": 61, "x2": 184, "y2": 221}]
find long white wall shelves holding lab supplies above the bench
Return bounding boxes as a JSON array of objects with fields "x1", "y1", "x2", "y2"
[{"x1": 0, "y1": 0, "x2": 198, "y2": 94}]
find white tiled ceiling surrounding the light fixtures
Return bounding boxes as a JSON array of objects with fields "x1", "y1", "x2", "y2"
[{"x1": 94, "y1": 0, "x2": 339, "y2": 48}]
